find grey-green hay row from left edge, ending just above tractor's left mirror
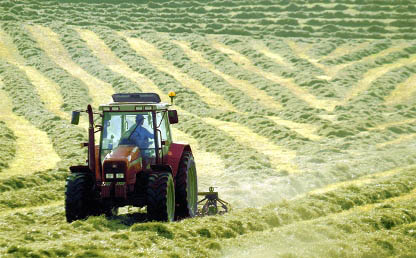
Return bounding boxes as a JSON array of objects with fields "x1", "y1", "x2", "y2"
[{"x1": 1, "y1": 23, "x2": 91, "y2": 112}]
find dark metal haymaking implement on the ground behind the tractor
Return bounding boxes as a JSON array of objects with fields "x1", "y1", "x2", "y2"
[{"x1": 197, "y1": 187, "x2": 231, "y2": 216}]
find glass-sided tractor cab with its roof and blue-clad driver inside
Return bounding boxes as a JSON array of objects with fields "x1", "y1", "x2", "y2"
[{"x1": 99, "y1": 93, "x2": 178, "y2": 173}]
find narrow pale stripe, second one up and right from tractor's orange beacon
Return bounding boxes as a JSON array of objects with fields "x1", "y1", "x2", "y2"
[{"x1": 173, "y1": 40, "x2": 282, "y2": 110}]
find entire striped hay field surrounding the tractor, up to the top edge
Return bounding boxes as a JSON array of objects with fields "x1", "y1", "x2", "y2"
[{"x1": 0, "y1": 0, "x2": 416, "y2": 257}]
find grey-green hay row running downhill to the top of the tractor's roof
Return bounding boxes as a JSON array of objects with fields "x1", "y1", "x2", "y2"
[{"x1": 51, "y1": 25, "x2": 140, "y2": 93}]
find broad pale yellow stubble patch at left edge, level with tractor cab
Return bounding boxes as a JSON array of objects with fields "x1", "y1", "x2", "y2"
[{"x1": 0, "y1": 81, "x2": 60, "y2": 178}]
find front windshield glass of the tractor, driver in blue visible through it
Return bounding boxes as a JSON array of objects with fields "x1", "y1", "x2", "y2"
[{"x1": 101, "y1": 112, "x2": 155, "y2": 160}]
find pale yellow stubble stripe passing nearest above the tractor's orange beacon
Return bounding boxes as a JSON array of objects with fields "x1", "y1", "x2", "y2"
[{"x1": 122, "y1": 33, "x2": 237, "y2": 111}]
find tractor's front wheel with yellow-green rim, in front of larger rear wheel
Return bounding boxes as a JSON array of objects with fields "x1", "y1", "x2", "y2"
[{"x1": 146, "y1": 172, "x2": 175, "y2": 221}]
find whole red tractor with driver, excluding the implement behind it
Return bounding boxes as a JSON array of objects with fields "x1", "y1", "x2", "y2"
[{"x1": 65, "y1": 93, "x2": 198, "y2": 222}]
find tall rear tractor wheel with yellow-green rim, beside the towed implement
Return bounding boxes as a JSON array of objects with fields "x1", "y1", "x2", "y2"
[{"x1": 175, "y1": 151, "x2": 198, "y2": 219}]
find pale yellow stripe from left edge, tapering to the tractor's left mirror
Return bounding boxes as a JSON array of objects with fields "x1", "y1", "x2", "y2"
[{"x1": 0, "y1": 29, "x2": 69, "y2": 119}]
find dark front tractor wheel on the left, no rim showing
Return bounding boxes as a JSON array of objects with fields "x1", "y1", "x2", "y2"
[{"x1": 65, "y1": 173, "x2": 95, "y2": 222}]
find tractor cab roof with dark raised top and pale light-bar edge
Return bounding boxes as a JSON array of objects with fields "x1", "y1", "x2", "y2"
[{"x1": 99, "y1": 93, "x2": 170, "y2": 111}]
